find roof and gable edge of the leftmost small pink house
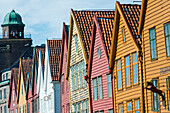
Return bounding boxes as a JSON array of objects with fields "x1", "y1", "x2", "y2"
[{"x1": 8, "y1": 68, "x2": 18, "y2": 108}]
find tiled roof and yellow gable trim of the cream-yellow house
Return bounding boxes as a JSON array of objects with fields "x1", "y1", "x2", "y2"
[{"x1": 66, "y1": 9, "x2": 113, "y2": 79}]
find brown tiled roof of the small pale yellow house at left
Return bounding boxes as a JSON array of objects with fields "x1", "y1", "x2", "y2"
[{"x1": 21, "y1": 59, "x2": 33, "y2": 87}]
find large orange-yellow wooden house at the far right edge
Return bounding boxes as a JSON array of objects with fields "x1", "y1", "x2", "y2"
[{"x1": 138, "y1": 0, "x2": 170, "y2": 113}]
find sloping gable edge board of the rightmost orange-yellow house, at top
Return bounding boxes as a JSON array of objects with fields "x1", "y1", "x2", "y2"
[{"x1": 138, "y1": 0, "x2": 147, "y2": 34}]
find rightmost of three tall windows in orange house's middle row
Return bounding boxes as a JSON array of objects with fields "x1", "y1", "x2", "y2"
[{"x1": 132, "y1": 53, "x2": 138, "y2": 84}]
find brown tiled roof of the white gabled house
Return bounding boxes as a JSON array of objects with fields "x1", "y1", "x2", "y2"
[{"x1": 48, "y1": 39, "x2": 62, "y2": 81}]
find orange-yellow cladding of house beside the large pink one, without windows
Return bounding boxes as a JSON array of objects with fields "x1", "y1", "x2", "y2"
[{"x1": 113, "y1": 16, "x2": 141, "y2": 113}]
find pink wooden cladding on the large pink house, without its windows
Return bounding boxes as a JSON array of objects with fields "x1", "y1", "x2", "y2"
[{"x1": 88, "y1": 24, "x2": 113, "y2": 112}]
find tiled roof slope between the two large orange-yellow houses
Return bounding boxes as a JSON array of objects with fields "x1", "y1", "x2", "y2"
[{"x1": 120, "y1": 4, "x2": 142, "y2": 48}]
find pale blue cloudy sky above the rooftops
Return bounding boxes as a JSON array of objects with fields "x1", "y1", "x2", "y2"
[{"x1": 0, "y1": 0, "x2": 141, "y2": 45}]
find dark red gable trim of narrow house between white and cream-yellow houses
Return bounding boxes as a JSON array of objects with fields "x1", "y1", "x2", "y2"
[{"x1": 58, "y1": 22, "x2": 69, "y2": 81}]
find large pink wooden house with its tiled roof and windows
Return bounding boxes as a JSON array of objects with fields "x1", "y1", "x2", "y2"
[{"x1": 87, "y1": 11, "x2": 114, "y2": 113}]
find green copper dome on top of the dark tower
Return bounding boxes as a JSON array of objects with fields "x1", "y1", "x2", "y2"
[{"x1": 1, "y1": 10, "x2": 24, "y2": 26}]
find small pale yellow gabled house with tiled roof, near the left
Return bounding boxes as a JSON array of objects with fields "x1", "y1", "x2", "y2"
[{"x1": 17, "y1": 59, "x2": 32, "y2": 113}]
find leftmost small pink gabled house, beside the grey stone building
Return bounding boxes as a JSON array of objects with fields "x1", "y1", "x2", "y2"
[{"x1": 8, "y1": 68, "x2": 19, "y2": 113}]
